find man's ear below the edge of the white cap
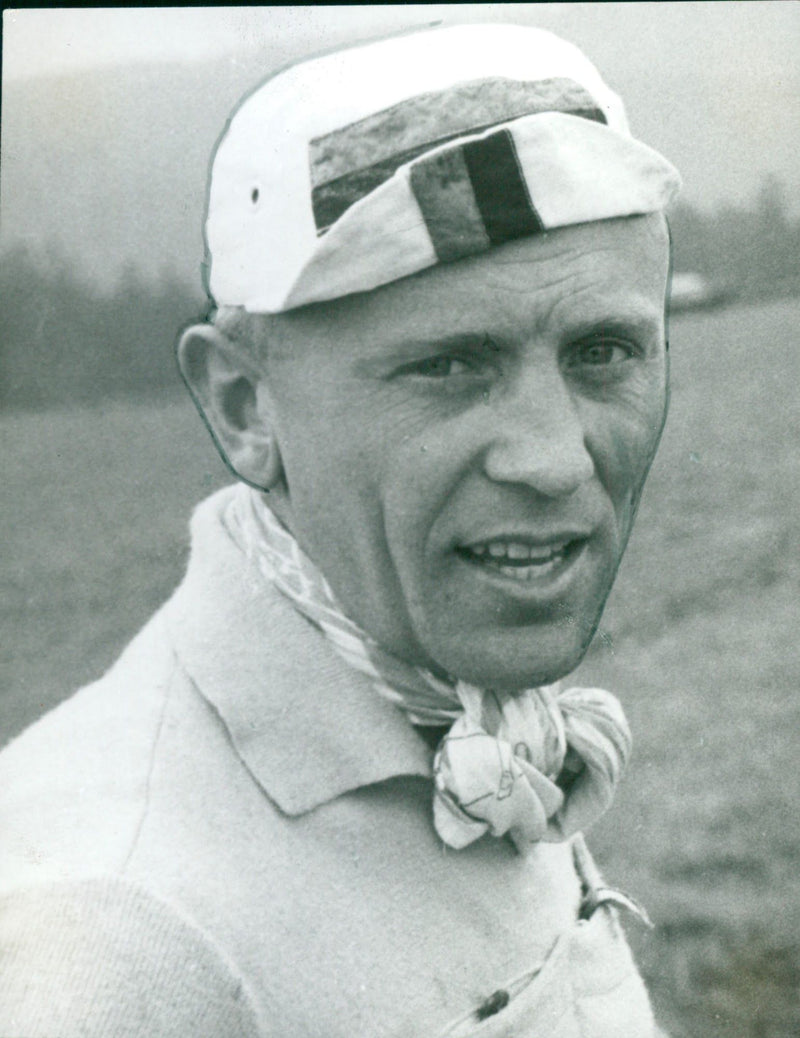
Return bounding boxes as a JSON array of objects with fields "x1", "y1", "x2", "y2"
[{"x1": 176, "y1": 324, "x2": 283, "y2": 490}]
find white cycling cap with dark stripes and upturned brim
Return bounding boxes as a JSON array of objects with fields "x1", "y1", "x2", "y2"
[{"x1": 205, "y1": 24, "x2": 680, "y2": 313}]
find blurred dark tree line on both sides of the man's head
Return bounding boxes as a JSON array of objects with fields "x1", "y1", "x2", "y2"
[{"x1": 0, "y1": 176, "x2": 800, "y2": 407}]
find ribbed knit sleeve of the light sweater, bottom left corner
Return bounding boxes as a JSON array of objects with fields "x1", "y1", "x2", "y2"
[{"x1": 0, "y1": 878, "x2": 265, "y2": 1038}]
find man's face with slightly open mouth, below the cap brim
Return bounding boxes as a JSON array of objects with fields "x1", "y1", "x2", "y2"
[{"x1": 267, "y1": 216, "x2": 668, "y2": 689}]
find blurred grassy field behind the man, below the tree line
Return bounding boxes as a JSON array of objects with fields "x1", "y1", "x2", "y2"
[{"x1": 0, "y1": 301, "x2": 800, "y2": 1038}]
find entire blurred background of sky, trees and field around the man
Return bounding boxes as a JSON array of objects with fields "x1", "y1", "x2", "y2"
[{"x1": 0, "y1": 2, "x2": 800, "y2": 1038}]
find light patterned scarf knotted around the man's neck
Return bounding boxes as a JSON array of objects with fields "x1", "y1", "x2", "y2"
[{"x1": 225, "y1": 484, "x2": 631, "y2": 849}]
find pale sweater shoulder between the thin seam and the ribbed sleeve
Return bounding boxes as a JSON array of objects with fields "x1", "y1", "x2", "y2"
[{"x1": 0, "y1": 614, "x2": 181, "y2": 891}]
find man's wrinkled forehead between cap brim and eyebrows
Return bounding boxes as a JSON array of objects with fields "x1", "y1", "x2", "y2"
[{"x1": 269, "y1": 214, "x2": 669, "y2": 352}]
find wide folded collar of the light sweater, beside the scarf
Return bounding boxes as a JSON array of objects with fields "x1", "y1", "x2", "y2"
[{"x1": 166, "y1": 487, "x2": 432, "y2": 815}]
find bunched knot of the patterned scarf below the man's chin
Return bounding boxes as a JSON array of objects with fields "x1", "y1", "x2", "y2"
[{"x1": 434, "y1": 684, "x2": 631, "y2": 848}]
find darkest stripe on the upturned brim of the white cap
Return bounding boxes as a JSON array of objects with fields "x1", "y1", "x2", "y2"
[{"x1": 463, "y1": 130, "x2": 544, "y2": 245}]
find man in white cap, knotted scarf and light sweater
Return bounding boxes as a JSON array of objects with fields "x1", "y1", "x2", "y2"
[{"x1": 0, "y1": 26, "x2": 678, "y2": 1038}]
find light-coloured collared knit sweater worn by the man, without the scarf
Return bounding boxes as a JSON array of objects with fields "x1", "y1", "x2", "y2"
[{"x1": 0, "y1": 491, "x2": 654, "y2": 1038}]
